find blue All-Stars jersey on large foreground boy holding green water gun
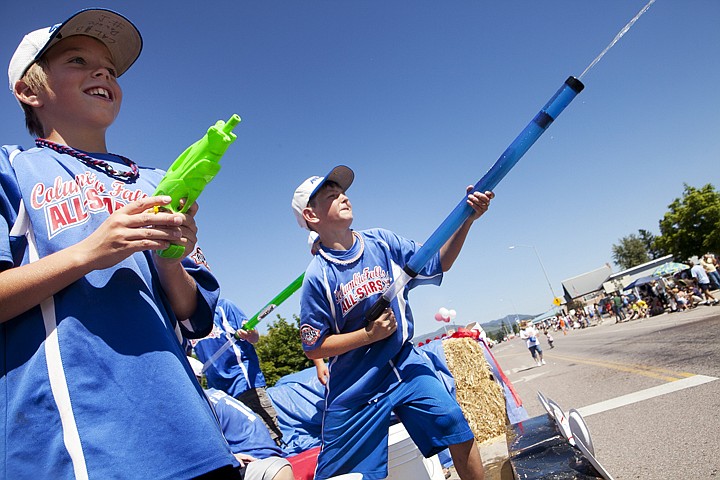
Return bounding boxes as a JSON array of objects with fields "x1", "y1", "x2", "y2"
[{"x1": 0, "y1": 146, "x2": 237, "y2": 479}]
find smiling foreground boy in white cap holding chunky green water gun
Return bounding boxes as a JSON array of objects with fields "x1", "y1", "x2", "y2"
[{"x1": 0, "y1": 9, "x2": 238, "y2": 479}]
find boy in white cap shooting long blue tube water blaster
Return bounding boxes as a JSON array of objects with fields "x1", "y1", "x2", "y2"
[{"x1": 292, "y1": 166, "x2": 493, "y2": 480}]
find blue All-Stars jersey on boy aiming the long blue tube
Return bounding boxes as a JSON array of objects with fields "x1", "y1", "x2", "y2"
[{"x1": 300, "y1": 229, "x2": 442, "y2": 410}]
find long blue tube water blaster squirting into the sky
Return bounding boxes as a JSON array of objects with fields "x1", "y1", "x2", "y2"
[{"x1": 365, "y1": 77, "x2": 585, "y2": 321}]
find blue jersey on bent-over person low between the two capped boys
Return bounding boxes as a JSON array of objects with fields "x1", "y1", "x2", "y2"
[{"x1": 205, "y1": 388, "x2": 285, "y2": 459}]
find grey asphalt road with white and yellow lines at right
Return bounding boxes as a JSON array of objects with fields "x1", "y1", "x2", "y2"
[{"x1": 492, "y1": 306, "x2": 720, "y2": 480}]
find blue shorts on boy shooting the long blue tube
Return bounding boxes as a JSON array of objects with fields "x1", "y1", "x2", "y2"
[{"x1": 315, "y1": 365, "x2": 474, "y2": 480}]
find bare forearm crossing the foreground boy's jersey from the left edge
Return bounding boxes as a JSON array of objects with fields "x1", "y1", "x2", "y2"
[{"x1": 0, "y1": 246, "x2": 92, "y2": 323}]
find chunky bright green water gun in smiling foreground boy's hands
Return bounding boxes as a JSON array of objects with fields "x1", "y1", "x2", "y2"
[{"x1": 153, "y1": 114, "x2": 240, "y2": 258}]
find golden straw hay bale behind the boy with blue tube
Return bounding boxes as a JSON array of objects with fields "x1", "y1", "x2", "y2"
[{"x1": 443, "y1": 338, "x2": 507, "y2": 442}]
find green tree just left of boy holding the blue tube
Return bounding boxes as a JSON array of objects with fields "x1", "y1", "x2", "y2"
[{"x1": 255, "y1": 315, "x2": 313, "y2": 387}]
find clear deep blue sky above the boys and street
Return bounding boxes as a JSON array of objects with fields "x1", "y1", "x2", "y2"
[{"x1": 0, "y1": 0, "x2": 720, "y2": 332}]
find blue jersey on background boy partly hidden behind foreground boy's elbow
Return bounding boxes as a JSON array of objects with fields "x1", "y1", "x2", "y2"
[{"x1": 195, "y1": 298, "x2": 266, "y2": 397}]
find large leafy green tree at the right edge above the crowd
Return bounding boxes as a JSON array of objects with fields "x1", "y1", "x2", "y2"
[{"x1": 655, "y1": 184, "x2": 720, "y2": 261}]
